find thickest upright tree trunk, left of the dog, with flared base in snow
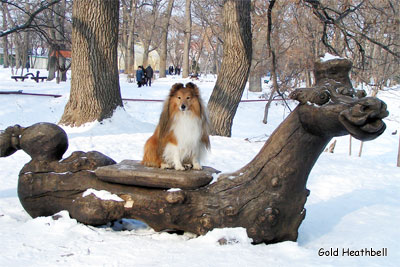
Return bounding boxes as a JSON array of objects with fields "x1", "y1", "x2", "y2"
[{"x1": 60, "y1": 0, "x2": 122, "y2": 126}]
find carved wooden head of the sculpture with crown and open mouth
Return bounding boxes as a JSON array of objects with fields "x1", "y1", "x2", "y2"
[{"x1": 289, "y1": 59, "x2": 389, "y2": 141}]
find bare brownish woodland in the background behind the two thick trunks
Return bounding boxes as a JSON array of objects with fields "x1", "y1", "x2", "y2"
[{"x1": 1, "y1": 0, "x2": 400, "y2": 87}]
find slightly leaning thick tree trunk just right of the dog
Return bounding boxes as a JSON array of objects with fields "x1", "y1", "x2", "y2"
[{"x1": 208, "y1": 0, "x2": 252, "y2": 136}]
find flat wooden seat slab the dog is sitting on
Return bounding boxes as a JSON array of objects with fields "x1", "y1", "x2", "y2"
[{"x1": 94, "y1": 160, "x2": 219, "y2": 189}]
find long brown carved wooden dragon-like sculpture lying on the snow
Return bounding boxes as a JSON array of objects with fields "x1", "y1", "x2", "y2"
[{"x1": 0, "y1": 59, "x2": 388, "y2": 243}]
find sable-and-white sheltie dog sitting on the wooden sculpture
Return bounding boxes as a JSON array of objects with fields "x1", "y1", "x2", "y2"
[{"x1": 142, "y1": 82, "x2": 210, "y2": 170}]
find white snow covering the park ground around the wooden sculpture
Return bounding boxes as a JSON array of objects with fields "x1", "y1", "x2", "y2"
[{"x1": 0, "y1": 69, "x2": 400, "y2": 266}]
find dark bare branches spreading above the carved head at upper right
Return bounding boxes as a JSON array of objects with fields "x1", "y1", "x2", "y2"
[{"x1": 303, "y1": 0, "x2": 400, "y2": 90}]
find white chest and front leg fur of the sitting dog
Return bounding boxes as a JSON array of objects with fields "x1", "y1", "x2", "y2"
[{"x1": 164, "y1": 111, "x2": 205, "y2": 168}]
